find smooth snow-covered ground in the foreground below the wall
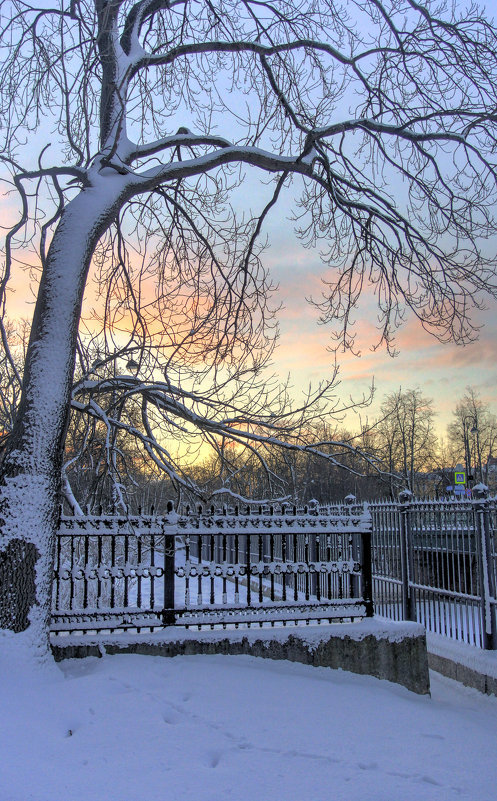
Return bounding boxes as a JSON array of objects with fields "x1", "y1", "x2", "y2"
[{"x1": 0, "y1": 636, "x2": 497, "y2": 801}]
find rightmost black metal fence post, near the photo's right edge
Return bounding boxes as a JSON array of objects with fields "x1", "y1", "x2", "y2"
[{"x1": 473, "y1": 484, "x2": 497, "y2": 651}]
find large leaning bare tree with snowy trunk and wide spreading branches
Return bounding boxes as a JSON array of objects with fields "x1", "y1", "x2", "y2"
[{"x1": 0, "y1": 0, "x2": 497, "y2": 642}]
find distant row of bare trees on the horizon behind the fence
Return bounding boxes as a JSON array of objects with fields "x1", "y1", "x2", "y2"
[{"x1": 0, "y1": 321, "x2": 497, "y2": 506}]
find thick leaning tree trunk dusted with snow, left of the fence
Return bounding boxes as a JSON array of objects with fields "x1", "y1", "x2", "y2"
[{"x1": 0, "y1": 185, "x2": 122, "y2": 650}]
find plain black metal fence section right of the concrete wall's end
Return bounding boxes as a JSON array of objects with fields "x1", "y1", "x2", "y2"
[{"x1": 362, "y1": 496, "x2": 497, "y2": 649}]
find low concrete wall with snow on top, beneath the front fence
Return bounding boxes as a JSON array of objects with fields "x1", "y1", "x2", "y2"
[{"x1": 52, "y1": 621, "x2": 430, "y2": 694}]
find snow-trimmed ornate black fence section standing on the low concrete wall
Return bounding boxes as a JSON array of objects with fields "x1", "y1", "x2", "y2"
[{"x1": 52, "y1": 507, "x2": 373, "y2": 633}]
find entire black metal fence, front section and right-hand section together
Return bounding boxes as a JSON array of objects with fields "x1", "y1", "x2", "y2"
[{"x1": 53, "y1": 493, "x2": 497, "y2": 649}]
